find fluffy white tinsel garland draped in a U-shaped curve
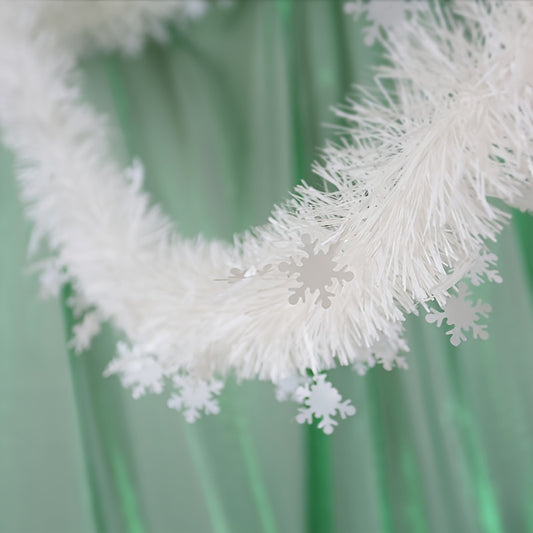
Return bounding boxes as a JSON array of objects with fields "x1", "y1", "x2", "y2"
[{"x1": 0, "y1": 1, "x2": 533, "y2": 381}]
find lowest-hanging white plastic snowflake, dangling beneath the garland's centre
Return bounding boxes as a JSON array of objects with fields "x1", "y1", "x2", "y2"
[{"x1": 296, "y1": 374, "x2": 355, "y2": 435}]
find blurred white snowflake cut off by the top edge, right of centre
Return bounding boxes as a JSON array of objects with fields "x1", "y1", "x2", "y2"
[{"x1": 344, "y1": 0, "x2": 426, "y2": 46}]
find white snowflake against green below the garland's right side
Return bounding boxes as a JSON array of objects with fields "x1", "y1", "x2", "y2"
[{"x1": 426, "y1": 283, "x2": 492, "y2": 346}]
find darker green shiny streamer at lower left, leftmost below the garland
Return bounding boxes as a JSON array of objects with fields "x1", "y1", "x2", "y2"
[{"x1": 61, "y1": 284, "x2": 146, "y2": 533}]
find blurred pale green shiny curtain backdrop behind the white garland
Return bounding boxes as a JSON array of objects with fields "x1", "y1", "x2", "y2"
[{"x1": 0, "y1": 0, "x2": 533, "y2": 533}]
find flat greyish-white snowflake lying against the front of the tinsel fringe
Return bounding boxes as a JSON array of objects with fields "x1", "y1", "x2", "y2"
[{"x1": 278, "y1": 234, "x2": 354, "y2": 309}]
